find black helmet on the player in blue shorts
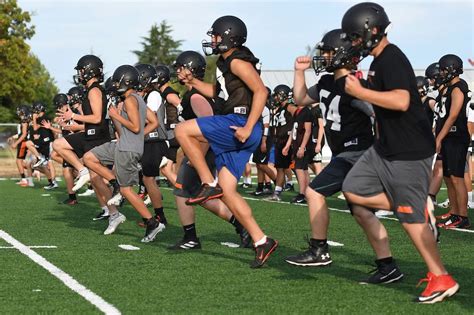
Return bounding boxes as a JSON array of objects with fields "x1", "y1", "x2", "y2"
[{"x1": 202, "y1": 15, "x2": 247, "y2": 56}]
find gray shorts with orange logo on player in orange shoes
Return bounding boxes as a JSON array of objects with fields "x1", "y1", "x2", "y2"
[{"x1": 342, "y1": 147, "x2": 433, "y2": 223}]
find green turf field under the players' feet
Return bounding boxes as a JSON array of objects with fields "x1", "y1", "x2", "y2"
[{"x1": 0, "y1": 180, "x2": 474, "y2": 314}]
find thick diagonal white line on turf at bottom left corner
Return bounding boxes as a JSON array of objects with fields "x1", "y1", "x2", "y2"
[{"x1": 0, "y1": 230, "x2": 121, "y2": 315}]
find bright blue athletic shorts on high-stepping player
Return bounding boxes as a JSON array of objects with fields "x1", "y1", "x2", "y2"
[{"x1": 196, "y1": 114, "x2": 262, "y2": 181}]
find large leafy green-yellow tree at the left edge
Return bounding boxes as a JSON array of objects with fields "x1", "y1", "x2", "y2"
[{"x1": 0, "y1": 0, "x2": 58, "y2": 122}]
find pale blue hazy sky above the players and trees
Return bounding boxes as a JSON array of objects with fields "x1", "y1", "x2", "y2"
[{"x1": 18, "y1": 0, "x2": 474, "y2": 92}]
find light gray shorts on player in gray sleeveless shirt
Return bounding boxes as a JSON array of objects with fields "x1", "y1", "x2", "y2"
[{"x1": 91, "y1": 142, "x2": 142, "y2": 187}]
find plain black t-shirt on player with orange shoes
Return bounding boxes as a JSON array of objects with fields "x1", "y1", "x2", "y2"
[{"x1": 368, "y1": 44, "x2": 435, "y2": 161}]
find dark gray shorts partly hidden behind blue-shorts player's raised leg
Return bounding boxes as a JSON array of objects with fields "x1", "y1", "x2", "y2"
[{"x1": 173, "y1": 151, "x2": 216, "y2": 198}]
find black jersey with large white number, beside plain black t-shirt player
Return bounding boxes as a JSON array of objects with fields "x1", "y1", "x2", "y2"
[{"x1": 308, "y1": 74, "x2": 374, "y2": 156}]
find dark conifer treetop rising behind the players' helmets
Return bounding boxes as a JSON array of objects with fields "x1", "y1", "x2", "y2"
[{"x1": 133, "y1": 21, "x2": 183, "y2": 65}]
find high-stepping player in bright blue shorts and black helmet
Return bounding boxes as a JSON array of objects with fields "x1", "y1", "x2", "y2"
[{"x1": 175, "y1": 16, "x2": 278, "y2": 268}]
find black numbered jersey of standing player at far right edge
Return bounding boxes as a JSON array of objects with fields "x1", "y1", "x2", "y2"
[{"x1": 439, "y1": 79, "x2": 471, "y2": 143}]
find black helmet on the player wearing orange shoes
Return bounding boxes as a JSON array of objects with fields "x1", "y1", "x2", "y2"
[{"x1": 341, "y1": 2, "x2": 390, "y2": 57}]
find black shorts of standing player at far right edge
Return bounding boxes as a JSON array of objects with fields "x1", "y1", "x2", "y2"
[{"x1": 441, "y1": 139, "x2": 469, "y2": 178}]
